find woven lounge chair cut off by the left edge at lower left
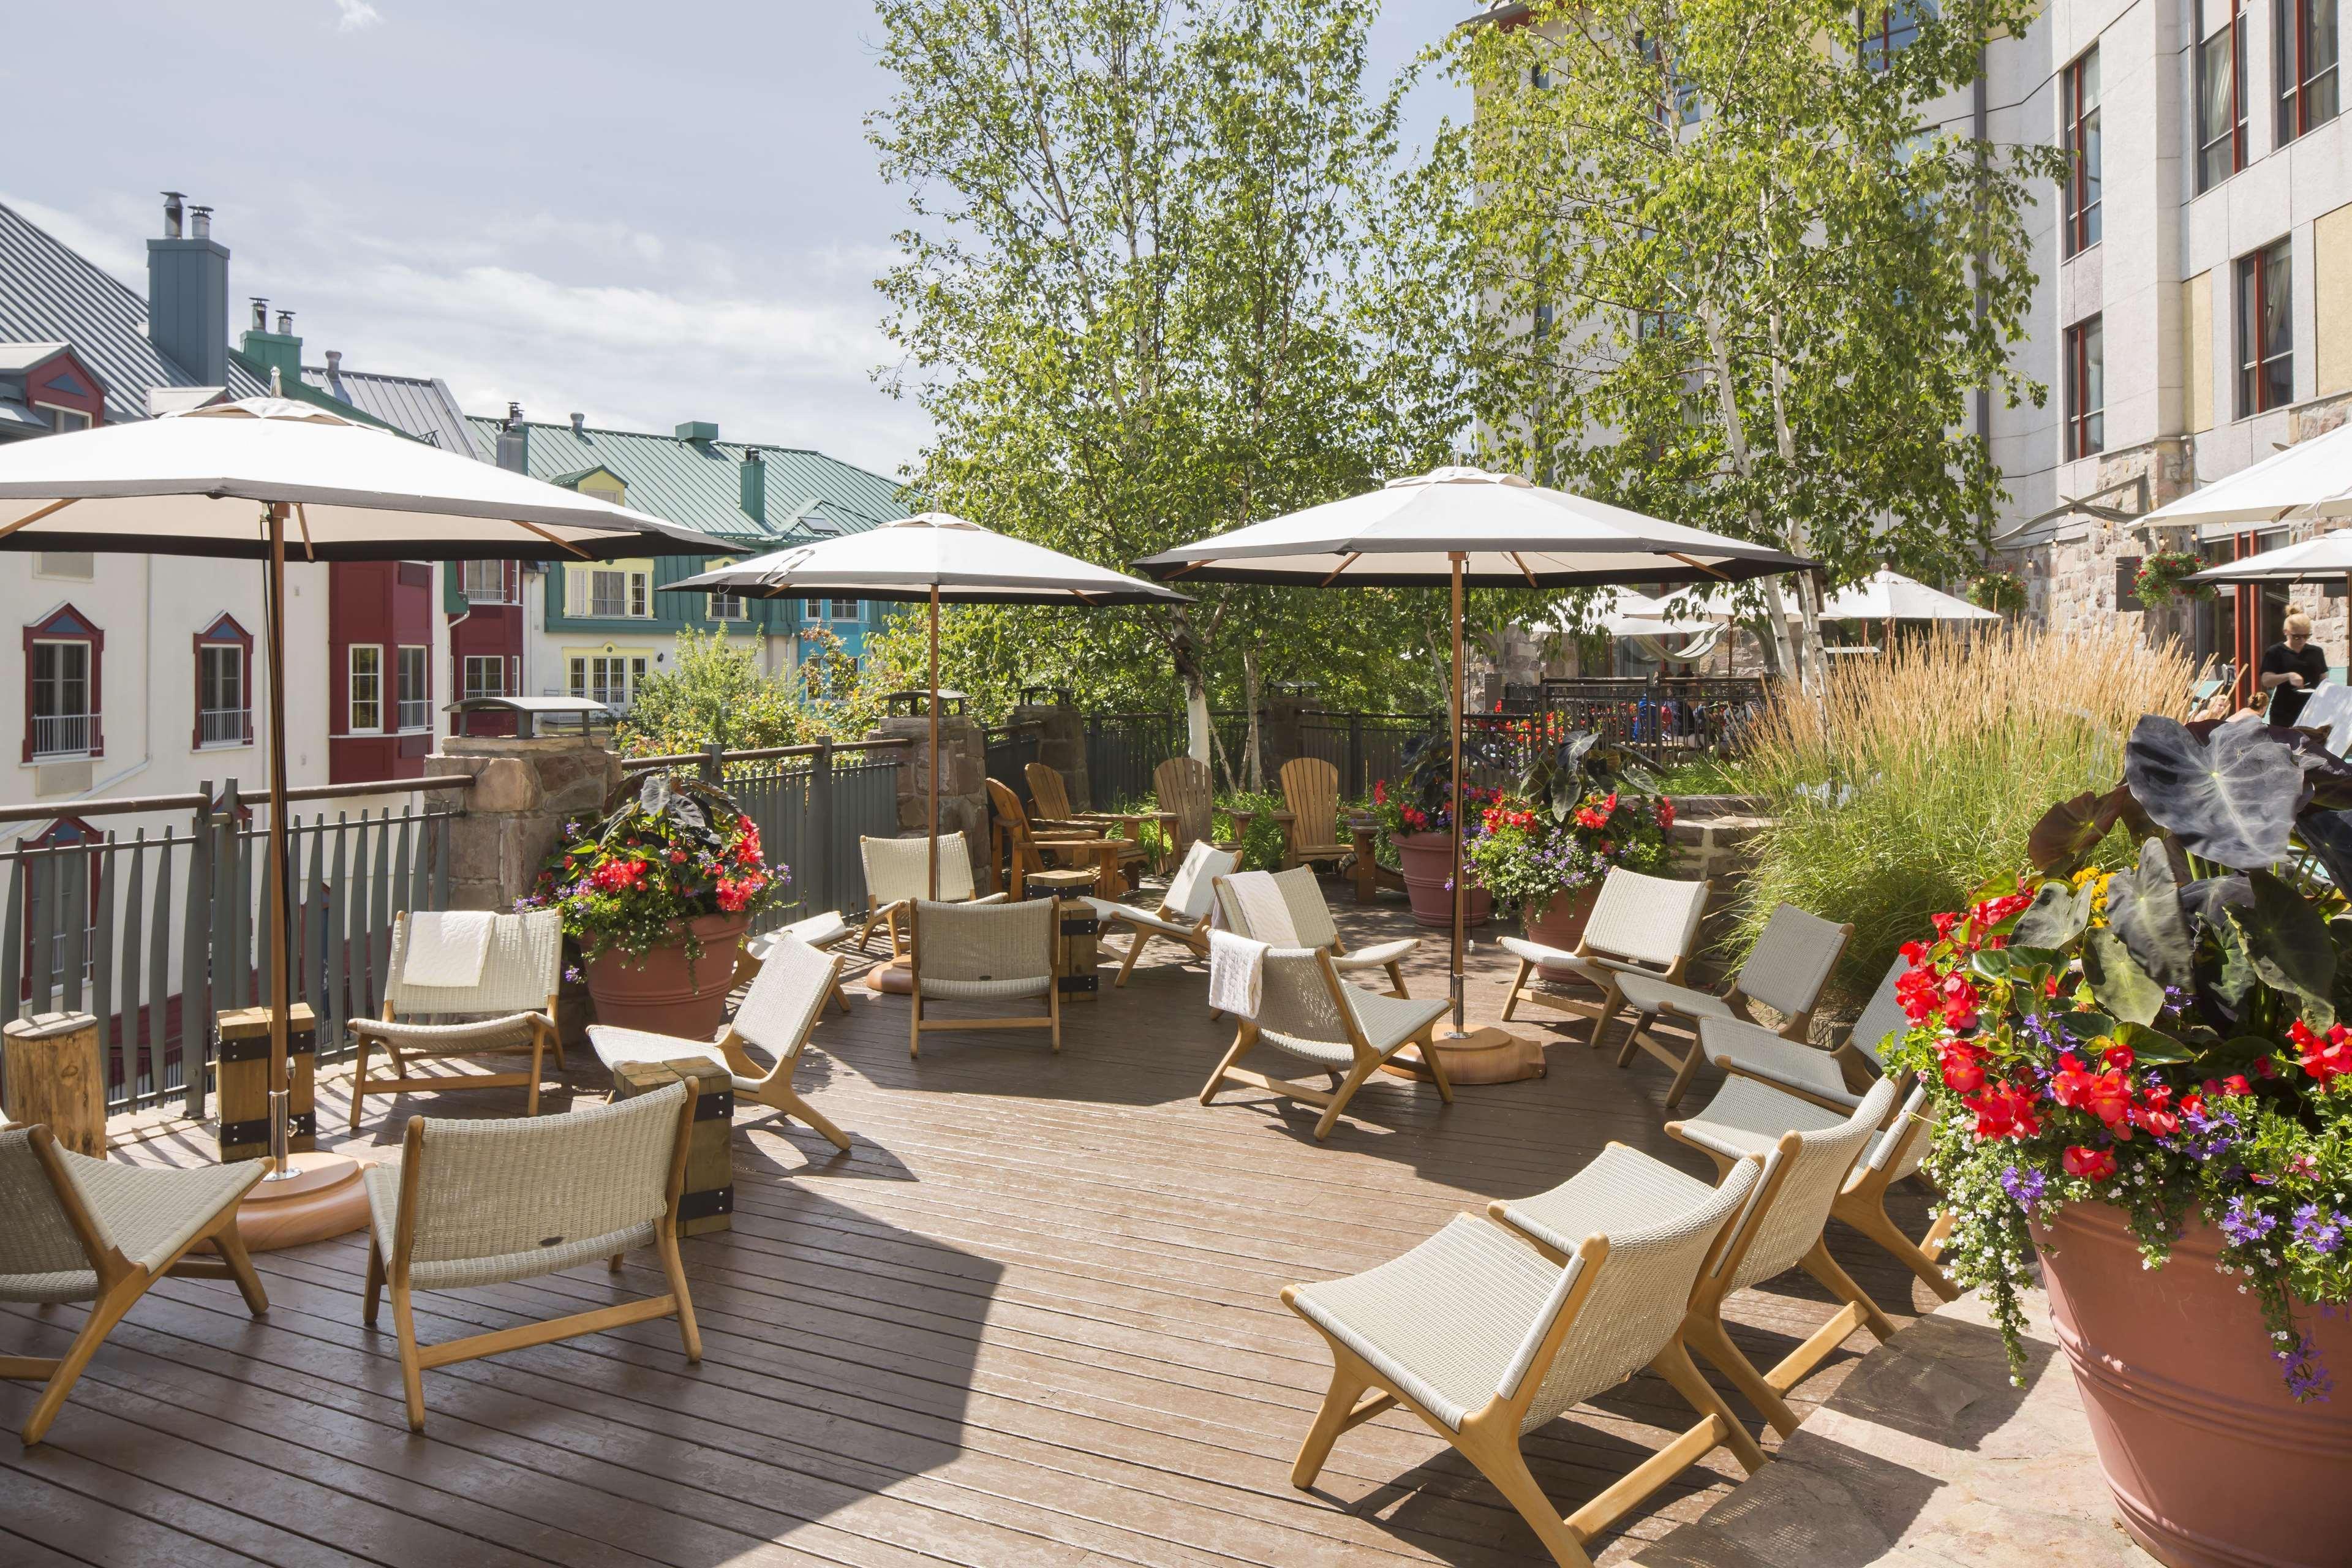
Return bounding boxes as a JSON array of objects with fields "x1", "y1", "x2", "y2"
[{"x1": 0, "y1": 1126, "x2": 271, "y2": 1448}]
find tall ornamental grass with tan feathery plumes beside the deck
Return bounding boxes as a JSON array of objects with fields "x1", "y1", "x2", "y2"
[{"x1": 1733, "y1": 625, "x2": 2195, "y2": 997}]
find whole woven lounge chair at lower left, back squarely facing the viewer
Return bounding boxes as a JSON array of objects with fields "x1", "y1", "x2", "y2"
[{"x1": 362, "y1": 1084, "x2": 703, "y2": 1431}]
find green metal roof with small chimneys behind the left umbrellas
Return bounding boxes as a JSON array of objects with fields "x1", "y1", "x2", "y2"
[{"x1": 466, "y1": 414, "x2": 913, "y2": 550}]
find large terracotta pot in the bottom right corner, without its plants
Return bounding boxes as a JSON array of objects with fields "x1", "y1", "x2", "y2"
[{"x1": 2035, "y1": 1204, "x2": 2352, "y2": 1568}]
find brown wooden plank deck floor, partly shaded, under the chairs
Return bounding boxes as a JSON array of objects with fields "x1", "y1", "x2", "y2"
[{"x1": 0, "y1": 884, "x2": 1933, "y2": 1568}]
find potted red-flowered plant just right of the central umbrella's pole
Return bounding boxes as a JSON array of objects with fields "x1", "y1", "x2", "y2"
[{"x1": 1468, "y1": 731, "x2": 1675, "y2": 980}]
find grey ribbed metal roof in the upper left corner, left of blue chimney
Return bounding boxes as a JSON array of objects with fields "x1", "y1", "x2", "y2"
[{"x1": 0, "y1": 202, "x2": 268, "y2": 421}]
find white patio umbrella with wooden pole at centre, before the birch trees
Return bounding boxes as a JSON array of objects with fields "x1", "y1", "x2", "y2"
[{"x1": 1136, "y1": 468, "x2": 1814, "y2": 1081}]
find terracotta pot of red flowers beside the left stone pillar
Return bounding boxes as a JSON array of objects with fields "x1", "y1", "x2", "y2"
[{"x1": 518, "y1": 774, "x2": 790, "y2": 1039}]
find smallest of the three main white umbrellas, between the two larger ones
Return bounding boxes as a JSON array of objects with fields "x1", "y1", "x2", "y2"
[{"x1": 668, "y1": 513, "x2": 1190, "y2": 898}]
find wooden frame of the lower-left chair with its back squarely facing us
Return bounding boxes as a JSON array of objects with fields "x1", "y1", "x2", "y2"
[{"x1": 360, "y1": 1079, "x2": 703, "y2": 1431}]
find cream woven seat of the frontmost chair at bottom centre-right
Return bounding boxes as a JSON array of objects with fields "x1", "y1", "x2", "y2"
[{"x1": 1296, "y1": 1215, "x2": 1562, "y2": 1431}]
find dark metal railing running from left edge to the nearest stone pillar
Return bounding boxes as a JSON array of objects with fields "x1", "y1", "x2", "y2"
[{"x1": 0, "y1": 778, "x2": 473, "y2": 1117}]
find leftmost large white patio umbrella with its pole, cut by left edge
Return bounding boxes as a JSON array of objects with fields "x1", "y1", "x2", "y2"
[{"x1": 0, "y1": 398, "x2": 741, "y2": 1234}]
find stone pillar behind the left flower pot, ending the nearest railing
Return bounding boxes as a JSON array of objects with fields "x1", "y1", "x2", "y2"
[{"x1": 426, "y1": 736, "x2": 621, "y2": 910}]
